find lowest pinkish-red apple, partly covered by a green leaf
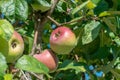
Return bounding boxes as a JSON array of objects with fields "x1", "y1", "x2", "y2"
[{"x1": 33, "y1": 49, "x2": 58, "y2": 72}]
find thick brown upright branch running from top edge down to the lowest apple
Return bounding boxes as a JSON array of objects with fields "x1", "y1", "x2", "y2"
[{"x1": 30, "y1": 0, "x2": 59, "y2": 55}]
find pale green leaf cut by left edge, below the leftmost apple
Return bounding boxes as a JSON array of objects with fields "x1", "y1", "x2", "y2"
[{"x1": 0, "y1": 52, "x2": 8, "y2": 77}]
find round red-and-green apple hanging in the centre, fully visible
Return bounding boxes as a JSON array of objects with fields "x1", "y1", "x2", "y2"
[{"x1": 50, "y1": 26, "x2": 77, "y2": 54}]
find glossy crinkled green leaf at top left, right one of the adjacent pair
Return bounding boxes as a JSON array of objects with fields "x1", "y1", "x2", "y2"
[{"x1": 15, "y1": 0, "x2": 28, "y2": 20}]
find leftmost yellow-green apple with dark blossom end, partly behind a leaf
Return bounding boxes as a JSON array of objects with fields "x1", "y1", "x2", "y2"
[{"x1": 4, "y1": 31, "x2": 24, "y2": 63}]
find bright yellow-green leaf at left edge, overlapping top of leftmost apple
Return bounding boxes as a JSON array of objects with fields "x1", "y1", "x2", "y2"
[{"x1": 0, "y1": 19, "x2": 14, "y2": 41}]
